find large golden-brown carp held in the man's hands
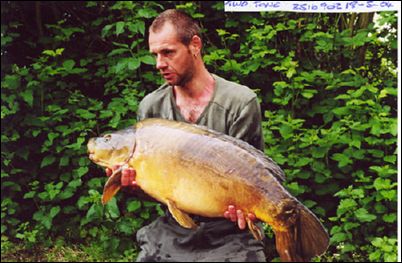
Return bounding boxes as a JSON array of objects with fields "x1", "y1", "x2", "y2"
[{"x1": 88, "y1": 119, "x2": 329, "y2": 261}]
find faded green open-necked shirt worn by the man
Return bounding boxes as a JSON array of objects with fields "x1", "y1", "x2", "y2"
[{"x1": 138, "y1": 74, "x2": 264, "y2": 150}]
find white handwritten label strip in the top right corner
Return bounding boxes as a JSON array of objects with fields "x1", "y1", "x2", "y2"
[{"x1": 225, "y1": 1, "x2": 401, "y2": 13}]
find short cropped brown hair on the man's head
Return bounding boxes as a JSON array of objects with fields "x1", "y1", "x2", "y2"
[{"x1": 149, "y1": 9, "x2": 201, "y2": 46}]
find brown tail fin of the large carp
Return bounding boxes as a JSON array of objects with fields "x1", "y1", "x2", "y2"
[{"x1": 274, "y1": 206, "x2": 329, "y2": 262}]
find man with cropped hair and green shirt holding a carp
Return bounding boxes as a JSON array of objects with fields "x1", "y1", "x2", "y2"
[{"x1": 107, "y1": 10, "x2": 265, "y2": 261}]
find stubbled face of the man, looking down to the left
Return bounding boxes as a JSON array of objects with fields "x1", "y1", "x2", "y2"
[{"x1": 149, "y1": 23, "x2": 195, "y2": 86}]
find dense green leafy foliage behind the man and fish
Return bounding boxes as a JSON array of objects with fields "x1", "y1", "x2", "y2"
[{"x1": 1, "y1": 1, "x2": 397, "y2": 261}]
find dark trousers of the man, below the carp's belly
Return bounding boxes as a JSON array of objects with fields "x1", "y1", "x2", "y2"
[{"x1": 137, "y1": 216, "x2": 266, "y2": 262}]
